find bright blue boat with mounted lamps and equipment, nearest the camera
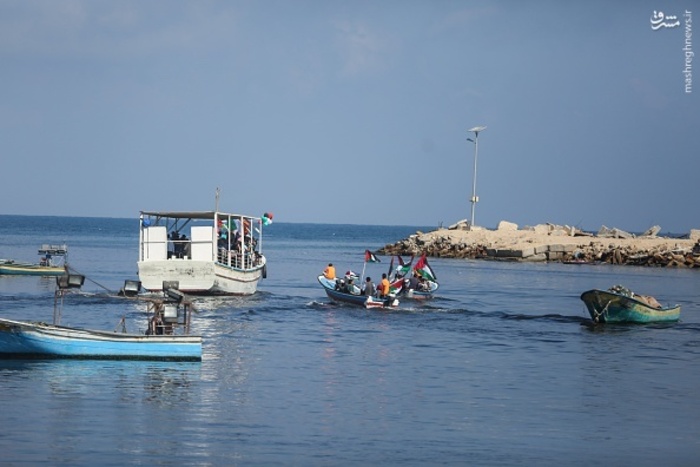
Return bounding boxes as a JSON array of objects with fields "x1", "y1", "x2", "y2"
[{"x1": 0, "y1": 275, "x2": 202, "y2": 361}]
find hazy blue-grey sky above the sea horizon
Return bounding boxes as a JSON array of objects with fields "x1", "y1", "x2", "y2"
[{"x1": 0, "y1": 0, "x2": 700, "y2": 233}]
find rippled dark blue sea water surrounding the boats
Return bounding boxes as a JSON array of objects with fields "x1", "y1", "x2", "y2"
[{"x1": 0, "y1": 216, "x2": 700, "y2": 466}]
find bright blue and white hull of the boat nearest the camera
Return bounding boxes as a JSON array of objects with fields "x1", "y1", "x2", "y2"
[{"x1": 0, "y1": 318, "x2": 202, "y2": 361}]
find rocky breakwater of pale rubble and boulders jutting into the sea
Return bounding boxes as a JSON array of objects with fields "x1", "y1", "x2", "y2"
[{"x1": 378, "y1": 221, "x2": 700, "y2": 268}]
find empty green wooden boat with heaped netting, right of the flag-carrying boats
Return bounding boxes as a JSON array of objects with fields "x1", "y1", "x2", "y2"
[{"x1": 581, "y1": 285, "x2": 681, "y2": 323}]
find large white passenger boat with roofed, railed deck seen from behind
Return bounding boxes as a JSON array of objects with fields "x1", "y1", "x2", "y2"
[{"x1": 138, "y1": 210, "x2": 267, "y2": 295}]
